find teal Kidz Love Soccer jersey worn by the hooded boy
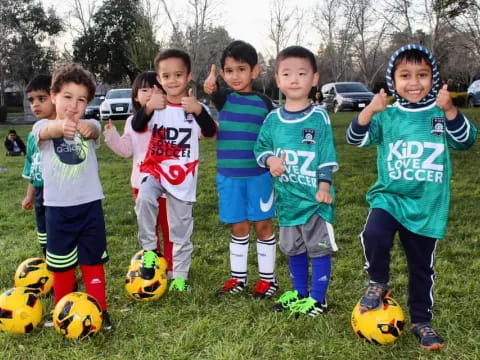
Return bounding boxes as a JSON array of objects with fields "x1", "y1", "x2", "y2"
[{"x1": 360, "y1": 104, "x2": 477, "y2": 239}]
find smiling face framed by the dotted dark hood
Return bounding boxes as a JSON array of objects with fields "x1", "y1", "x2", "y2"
[{"x1": 393, "y1": 60, "x2": 433, "y2": 103}]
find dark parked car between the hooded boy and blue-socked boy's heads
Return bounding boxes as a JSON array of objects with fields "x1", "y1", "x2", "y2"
[{"x1": 321, "y1": 82, "x2": 374, "y2": 112}]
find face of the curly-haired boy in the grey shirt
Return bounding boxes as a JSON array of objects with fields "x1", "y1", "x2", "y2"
[{"x1": 52, "y1": 82, "x2": 88, "y2": 122}]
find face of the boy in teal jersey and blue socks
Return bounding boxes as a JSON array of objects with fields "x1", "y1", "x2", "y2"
[{"x1": 275, "y1": 57, "x2": 319, "y2": 101}]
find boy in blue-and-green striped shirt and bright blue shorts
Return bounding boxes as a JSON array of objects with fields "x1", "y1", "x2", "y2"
[{"x1": 204, "y1": 40, "x2": 278, "y2": 299}]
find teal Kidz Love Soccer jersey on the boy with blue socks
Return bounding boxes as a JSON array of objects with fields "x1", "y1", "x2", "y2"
[{"x1": 254, "y1": 106, "x2": 338, "y2": 226}]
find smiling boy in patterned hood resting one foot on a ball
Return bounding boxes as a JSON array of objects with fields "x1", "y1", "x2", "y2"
[{"x1": 347, "y1": 45, "x2": 477, "y2": 350}]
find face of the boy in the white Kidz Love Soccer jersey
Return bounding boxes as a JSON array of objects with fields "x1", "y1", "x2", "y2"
[{"x1": 157, "y1": 58, "x2": 192, "y2": 103}]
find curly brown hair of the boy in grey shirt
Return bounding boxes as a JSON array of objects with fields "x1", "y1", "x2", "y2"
[{"x1": 51, "y1": 64, "x2": 96, "y2": 101}]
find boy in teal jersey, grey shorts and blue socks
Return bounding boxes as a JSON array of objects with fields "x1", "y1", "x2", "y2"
[{"x1": 254, "y1": 46, "x2": 338, "y2": 317}]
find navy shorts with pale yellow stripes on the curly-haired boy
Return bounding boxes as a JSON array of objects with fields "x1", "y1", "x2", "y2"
[{"x1": 46, "y1": 200, "x2": 108, "y2": 272}]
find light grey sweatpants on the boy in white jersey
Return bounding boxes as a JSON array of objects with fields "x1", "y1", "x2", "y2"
[{"x1": 135, "y1": 175, "x2": 193, "y2": 279}]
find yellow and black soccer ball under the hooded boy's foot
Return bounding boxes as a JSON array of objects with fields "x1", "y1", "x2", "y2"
[{"x1": 352, "y1": 297, "x2": 405, "y2": 344}]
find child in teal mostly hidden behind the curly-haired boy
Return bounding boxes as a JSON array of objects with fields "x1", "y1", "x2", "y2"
[{"x1": 22, "y1": 75, "x2": 57, "y2": 255}]
